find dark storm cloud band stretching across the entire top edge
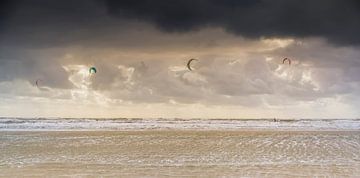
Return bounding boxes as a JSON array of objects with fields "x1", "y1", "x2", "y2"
[{"x1": 0, "y1": 0, "x2": 360, "y2": 47}]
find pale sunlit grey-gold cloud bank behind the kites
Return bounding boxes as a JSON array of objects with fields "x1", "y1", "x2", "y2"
[{"x1": 0, "y1": 30, "x2": 360, "y2": 106}]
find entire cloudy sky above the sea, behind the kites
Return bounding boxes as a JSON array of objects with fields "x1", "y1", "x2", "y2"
[{"x1": 0, "y1": 0, "x2": 360, "y2": 118}]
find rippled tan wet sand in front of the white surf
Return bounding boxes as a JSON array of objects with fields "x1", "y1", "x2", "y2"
[{"x1": 0, "y1": 130, "x2": 360, "y2": 177}]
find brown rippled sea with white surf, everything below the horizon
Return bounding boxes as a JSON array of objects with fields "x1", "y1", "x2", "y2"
[{"x1": 0, "y1": 117, "x2": 360, "y2": 177}]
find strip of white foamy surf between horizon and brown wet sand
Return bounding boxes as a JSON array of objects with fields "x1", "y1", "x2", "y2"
[{"x1": 0, "y1": 118, "x2": 360, "y2": 130}]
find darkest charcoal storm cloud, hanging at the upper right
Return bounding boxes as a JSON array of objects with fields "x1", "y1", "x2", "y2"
[{"x1": 107, "y1": 0, "x2": 360, "y2": 44}]
